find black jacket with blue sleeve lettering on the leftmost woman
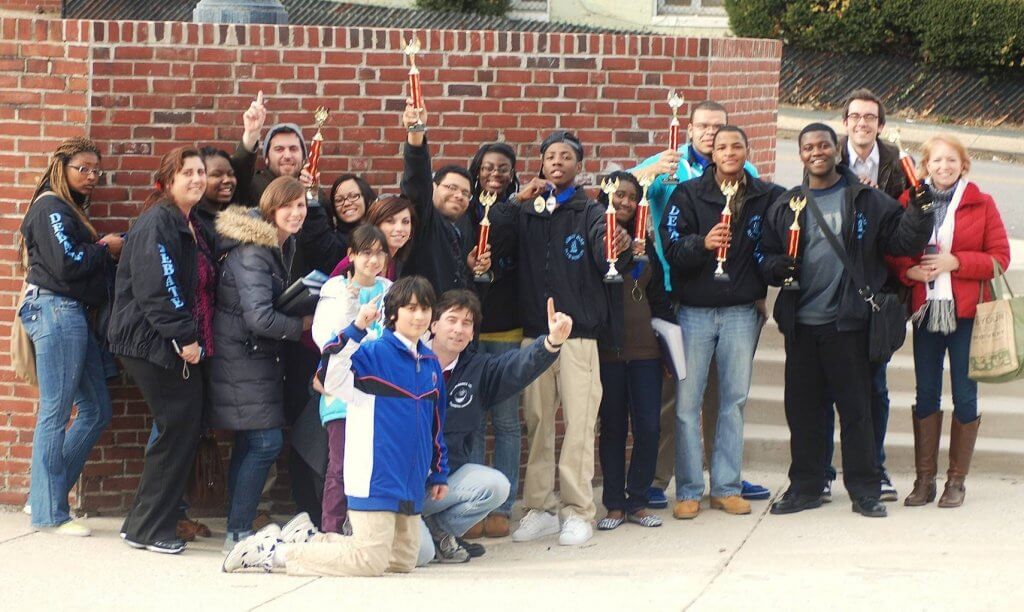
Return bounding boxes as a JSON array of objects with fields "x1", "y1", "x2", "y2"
[{"x1": 22, "y1": 193, "x2": 114, "y2": 306}]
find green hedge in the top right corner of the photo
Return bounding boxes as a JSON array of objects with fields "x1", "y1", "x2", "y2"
[{"x1": 725, "y1": 0, "x2": 1024, "y2": 73}]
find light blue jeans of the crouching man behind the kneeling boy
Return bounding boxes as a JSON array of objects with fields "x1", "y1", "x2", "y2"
[{"x1": 416, "y1": 464, "x2": 511, "y2": 566}]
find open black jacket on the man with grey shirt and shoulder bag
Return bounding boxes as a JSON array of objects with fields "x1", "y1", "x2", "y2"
[{"x1": 760, "y1": 166, "x2": 935, "y2": 335}]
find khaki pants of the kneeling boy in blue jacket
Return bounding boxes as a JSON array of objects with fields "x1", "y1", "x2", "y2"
[{"x1": 285, "y1": 510, "x2": 420, "y2": 576}]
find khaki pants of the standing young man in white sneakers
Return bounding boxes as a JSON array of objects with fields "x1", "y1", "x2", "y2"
[{"x1": 522, "y1": 338, "x2": 601, "y2": 521}]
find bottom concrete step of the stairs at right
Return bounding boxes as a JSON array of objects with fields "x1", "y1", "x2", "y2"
[{"x1": 743, "y1": 423, "x2": 1024, "y2": 476}]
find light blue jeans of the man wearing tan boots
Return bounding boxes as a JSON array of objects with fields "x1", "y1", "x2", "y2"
[{"x1": 676, "y1": 304, "x2": 763, "y2": 500}]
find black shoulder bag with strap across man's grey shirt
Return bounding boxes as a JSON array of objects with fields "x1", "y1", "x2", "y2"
[{"x1": 801, "y1": 186, "x2": 906, "y2": 363}]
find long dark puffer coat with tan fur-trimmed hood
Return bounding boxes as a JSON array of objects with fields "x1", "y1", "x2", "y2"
[{"x1": 209, "y1": 207, "x2": 302, "y2": 430}]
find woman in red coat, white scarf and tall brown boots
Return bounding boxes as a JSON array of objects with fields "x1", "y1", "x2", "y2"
[{"x1": 893, "y1": 135, "x2": 1010, "y2": 508}]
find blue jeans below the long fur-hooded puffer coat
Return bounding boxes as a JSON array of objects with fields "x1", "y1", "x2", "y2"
[{"x1": 227, "y1": 428, "x2": 285, "y2": 540}]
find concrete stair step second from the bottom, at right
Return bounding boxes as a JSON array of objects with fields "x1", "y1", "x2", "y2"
[{"x1": 743, "y1": 385, "x2": 1024, "y2": 445}]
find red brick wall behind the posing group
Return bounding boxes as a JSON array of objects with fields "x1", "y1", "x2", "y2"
[{"x1": 0, "y1": 17, "x2": 781, "y2": 511}]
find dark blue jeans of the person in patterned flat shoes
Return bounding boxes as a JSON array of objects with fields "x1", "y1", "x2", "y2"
[{"x1": 598, "y1": 359, "x2": 664, "y2": 513}]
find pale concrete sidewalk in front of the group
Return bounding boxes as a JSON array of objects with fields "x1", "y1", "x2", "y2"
[{"x1": 0, "y1": 472, "x2": 1024, "y2": 612}]
